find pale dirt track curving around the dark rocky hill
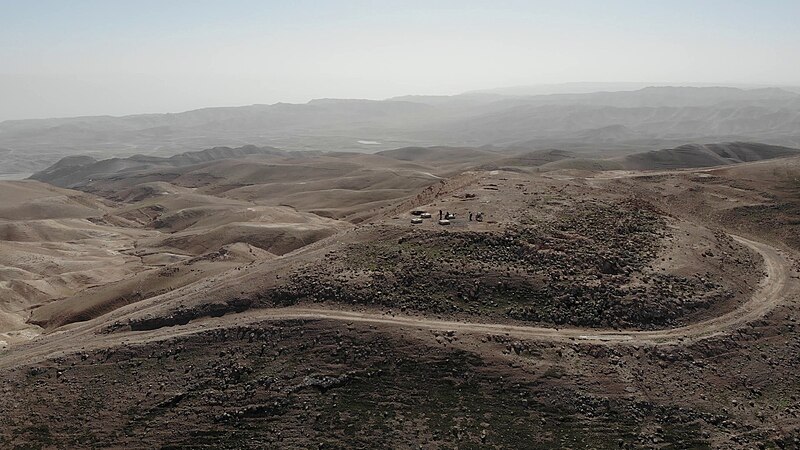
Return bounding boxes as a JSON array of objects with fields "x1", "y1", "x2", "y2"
[{"x1": 0, "y1": 236, "x2": 798, "y2": 368}]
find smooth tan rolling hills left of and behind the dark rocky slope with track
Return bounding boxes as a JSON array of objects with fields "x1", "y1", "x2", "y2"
[{"x1": 0, "y1": 146, "x2": 462, "y2": 343}]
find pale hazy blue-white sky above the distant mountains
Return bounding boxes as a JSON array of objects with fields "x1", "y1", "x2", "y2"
[{"x1": 0, "y1": 0, "x2": 800, "y2": 120}]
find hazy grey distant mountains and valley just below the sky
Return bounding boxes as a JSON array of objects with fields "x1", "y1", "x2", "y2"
[{"x1": 0, "y1": 86, "x2": 800, "y2": 172}]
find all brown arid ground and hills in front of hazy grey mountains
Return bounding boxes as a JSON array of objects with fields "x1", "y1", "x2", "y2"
[{"x1": 0, "y1": 140, "x2": 800, "y2": 449}]
